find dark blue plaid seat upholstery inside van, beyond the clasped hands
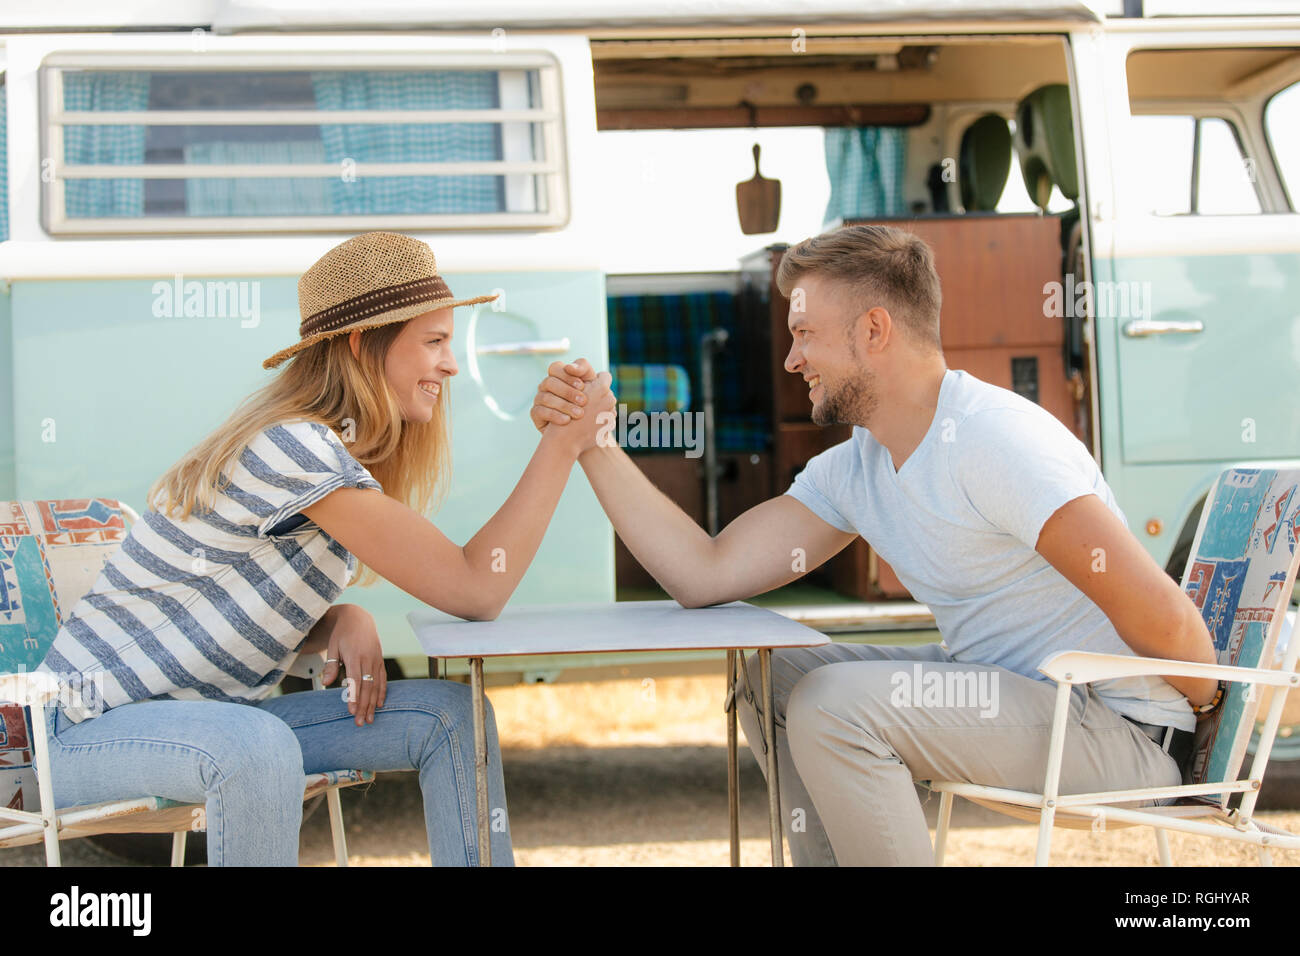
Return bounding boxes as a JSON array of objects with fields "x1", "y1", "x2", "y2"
[{"x1": 607, "y1": 293, "x2": 771, "y2": 451}]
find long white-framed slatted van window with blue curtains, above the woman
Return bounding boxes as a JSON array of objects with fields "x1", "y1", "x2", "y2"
[{"x1": 42, "y1": 53, "x2": 566, "y2": 233}]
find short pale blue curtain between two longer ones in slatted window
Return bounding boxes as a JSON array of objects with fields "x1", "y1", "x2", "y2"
[{"x1": 185, "y1": 139, "x2": 330, "y2": 216}]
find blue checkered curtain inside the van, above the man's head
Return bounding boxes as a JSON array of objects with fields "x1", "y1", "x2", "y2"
[{"x1": 826, "y1": 126, "x2": 907, "y2": 220}]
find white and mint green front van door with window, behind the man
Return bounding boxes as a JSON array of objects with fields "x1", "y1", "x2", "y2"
[{"x1": 1073, "y1": 27, "x2": 1300, "y2": 572}]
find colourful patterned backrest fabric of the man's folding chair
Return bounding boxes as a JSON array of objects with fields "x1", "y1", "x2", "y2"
[{"x1": 1183, "y1": 468, "x2": 1300, "y2": 783}]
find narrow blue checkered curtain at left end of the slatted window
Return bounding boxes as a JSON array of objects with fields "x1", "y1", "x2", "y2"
[{"x1": 64, "y1": 70, "x2": 150, "y2": 219}]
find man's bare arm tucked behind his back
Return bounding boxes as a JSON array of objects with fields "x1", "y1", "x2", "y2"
[{"x1": 1036, "y1": 494, "x2": 1217, "y2": 704}]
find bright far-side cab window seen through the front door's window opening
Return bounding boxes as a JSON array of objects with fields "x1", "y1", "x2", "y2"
[{"x1": 1132, "y1": 114, "x2": 1260, "y2": 216}]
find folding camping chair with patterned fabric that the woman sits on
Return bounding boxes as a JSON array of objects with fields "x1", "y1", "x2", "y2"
[{"x1": 0, "y1": 498, "x2": 374, "y2": 866}]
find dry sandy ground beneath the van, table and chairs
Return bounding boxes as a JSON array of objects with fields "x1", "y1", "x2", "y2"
[{"x1": 0, "y1": 674, "x2": 1300, "y2": 866}]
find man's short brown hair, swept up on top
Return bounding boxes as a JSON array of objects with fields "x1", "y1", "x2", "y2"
[{"x1": 776, "y1": 225, "x2": 943, "y2": 349}]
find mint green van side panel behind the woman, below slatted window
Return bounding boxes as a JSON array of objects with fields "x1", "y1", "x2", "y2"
[{"x1": 10, "y1": 271, "x2": 614, "y2": 657}]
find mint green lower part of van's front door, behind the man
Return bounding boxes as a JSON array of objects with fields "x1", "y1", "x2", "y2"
[{"x1": 1095, "y1": 254, "x2": 1300, "y2": 567}]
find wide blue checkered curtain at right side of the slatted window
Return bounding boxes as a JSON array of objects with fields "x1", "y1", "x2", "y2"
[{"x1": 312, "y1": 70, "x2": 504, "y2": 215}]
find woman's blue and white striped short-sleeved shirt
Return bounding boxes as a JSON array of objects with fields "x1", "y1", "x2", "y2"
[{"x1": 40, "y1": 420, "x2": 384, "y2": 722}]
